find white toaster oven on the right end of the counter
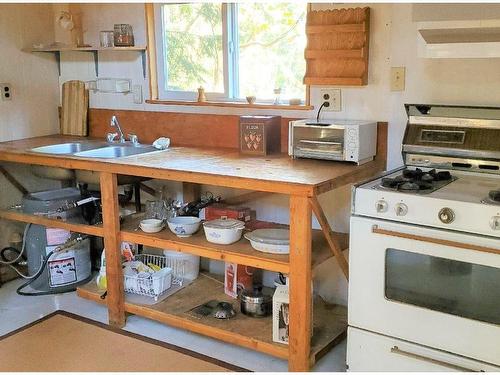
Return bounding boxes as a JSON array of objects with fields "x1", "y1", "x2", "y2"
[{"x1": 288, "y1": 120, "x2": 377, "y2": 165}]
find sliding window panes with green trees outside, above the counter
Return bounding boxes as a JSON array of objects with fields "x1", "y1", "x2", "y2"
[{"x1": 155, "y1": 2, "x2": 307, "y2": 104}]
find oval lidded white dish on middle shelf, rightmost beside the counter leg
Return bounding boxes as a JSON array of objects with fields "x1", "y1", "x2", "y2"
[{"x1": 245, "y1": 229, "x2": 290, "y2": 254}]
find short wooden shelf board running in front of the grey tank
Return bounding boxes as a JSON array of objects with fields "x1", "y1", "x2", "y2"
[{"x1": 0, "y1": 209, "x2": 104, "y2": 237}]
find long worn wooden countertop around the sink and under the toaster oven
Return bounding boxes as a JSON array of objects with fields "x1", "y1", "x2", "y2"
[{"x1": 0, "y1": 135, "x2": 385, "y2": 196}]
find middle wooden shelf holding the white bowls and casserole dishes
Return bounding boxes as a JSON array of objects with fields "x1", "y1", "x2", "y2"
[{"x1": 121, "y1": 217, "x2": 348, "y2": 273}]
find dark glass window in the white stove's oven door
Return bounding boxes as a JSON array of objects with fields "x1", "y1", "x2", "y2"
[{"x1": 385, "y1": 249, "x2": 500, "y2": 324}]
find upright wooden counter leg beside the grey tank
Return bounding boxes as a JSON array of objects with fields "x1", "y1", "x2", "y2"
[{"x1": 101, "y1": 172, "x2": 125, "y2": 328}]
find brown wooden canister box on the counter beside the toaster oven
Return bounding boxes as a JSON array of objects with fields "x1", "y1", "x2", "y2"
[{"x1": 240, "y1": 116, "x2": 281, "y2": 156}]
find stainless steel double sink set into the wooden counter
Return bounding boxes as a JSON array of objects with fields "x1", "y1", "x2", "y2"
[{"x1": 30, "y1": 142, "x2": 158, "y2": 159}]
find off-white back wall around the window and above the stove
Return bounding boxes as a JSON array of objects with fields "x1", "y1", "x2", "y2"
[{"x1": 57, "y1": 3, "x2": 500, "y2": 303}]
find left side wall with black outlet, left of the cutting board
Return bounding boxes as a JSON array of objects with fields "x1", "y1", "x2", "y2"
[{"x1": 0, "y1": 4, "x2": 59, "y2": 141}]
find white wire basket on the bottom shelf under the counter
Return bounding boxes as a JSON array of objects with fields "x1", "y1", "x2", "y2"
[{"x1": 123, "y1": 254, "x2": 186, "y2": 301}]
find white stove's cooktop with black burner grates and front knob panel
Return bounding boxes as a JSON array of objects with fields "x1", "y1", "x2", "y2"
[{"x1": 353, "y1": 167, "x2": 500, "y2": 237}]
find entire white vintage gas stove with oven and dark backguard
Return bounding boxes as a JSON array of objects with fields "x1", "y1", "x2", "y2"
[{"x1": 347, "y1": 105, "x2": 500, "y2": 371}]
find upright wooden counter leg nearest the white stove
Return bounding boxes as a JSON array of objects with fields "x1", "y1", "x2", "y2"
[{"x1": 288, "y1": 195, "x2": 312, "y2": 371}]
